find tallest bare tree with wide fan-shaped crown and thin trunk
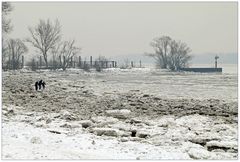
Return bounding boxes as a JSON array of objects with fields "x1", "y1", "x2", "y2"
[{"x1": 27, "y1": 19, "x2": 61, "y2": 67}]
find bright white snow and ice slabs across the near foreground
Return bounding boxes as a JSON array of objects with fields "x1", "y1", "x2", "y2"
[{"x1": 2, "y1": 109, "x2": 237, "y2": 159}]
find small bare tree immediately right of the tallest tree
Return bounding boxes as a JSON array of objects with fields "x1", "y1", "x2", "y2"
[{"x1": 60, "y1": 40, "x2": 81, "y2": 70}]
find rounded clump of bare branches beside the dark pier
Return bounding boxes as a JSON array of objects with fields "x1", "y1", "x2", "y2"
[{"x1": 147, "y1": 36, "x2": 191, "y2": 70}]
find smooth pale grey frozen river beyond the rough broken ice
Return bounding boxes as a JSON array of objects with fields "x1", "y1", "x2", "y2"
[{"x1": 57, "y1": 68, "x2": 238, "y2": 101}]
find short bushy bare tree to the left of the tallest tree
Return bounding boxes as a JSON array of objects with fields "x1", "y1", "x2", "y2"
[{"x1": 8, "y1": 39, "x2": 28, "y2": 70}]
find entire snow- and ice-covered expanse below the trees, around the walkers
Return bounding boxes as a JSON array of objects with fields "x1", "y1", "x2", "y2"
[{"x1": 2, "y1": 68, "x2": 238, "y2": 159}]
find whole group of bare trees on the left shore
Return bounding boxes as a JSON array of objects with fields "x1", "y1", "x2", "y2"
[{"x1": 2, "y1": 2, "x2": 81, "y2": 70}]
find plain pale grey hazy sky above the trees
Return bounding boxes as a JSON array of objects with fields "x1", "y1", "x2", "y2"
[{"x1": 10, "y1": 2, "x2": 238, "y2": 56}]
